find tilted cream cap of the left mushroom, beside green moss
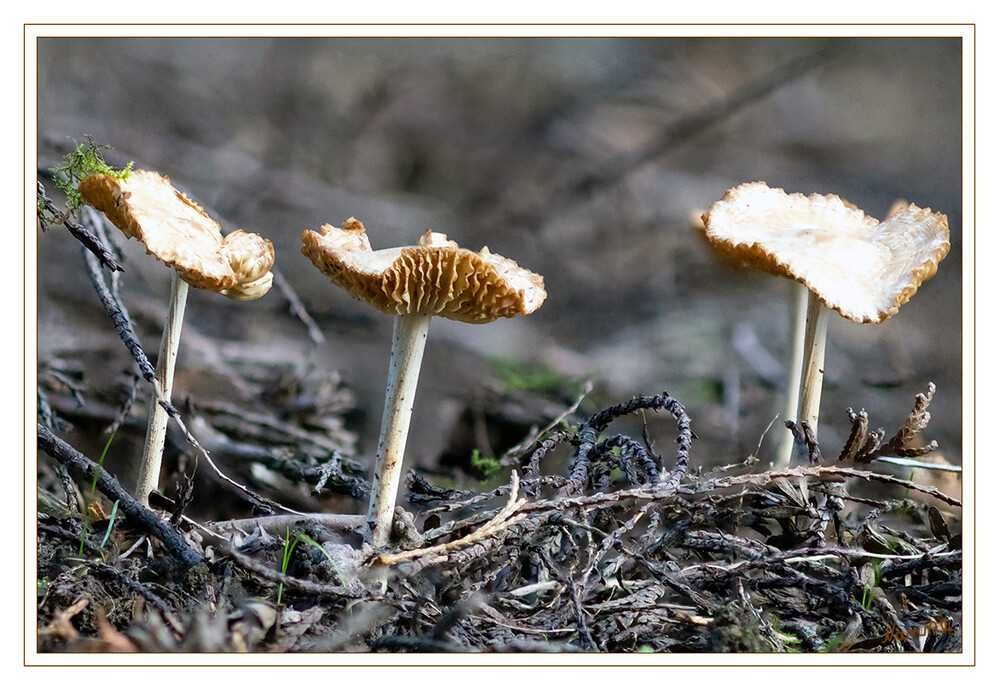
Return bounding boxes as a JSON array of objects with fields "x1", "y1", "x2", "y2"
[{"x1": 79, "y1": 170, "x2": 274, "y2": 300}]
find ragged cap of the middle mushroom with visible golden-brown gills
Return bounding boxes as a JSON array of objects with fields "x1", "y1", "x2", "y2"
[{"x1": 302, "y1": 218, "x2": 547, "y2": 323}]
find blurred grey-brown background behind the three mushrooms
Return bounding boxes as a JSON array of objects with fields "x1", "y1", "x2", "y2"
[{"x1": 37, "y1": 38, "x2": 962, "y2": 510}]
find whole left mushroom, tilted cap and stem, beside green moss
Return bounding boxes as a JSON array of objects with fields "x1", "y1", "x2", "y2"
[{"x1": 79, "y1": 170, "x2": 274, "y2": 506}]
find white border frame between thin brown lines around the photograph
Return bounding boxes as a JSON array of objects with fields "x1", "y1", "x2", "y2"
[{"x1": 23, "y1": 23, "x2": 978, "y2": 667}]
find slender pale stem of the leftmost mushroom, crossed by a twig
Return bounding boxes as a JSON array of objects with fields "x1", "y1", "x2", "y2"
[{"x1": 135, "y1": 271, "x2": 188, "y2": 508}]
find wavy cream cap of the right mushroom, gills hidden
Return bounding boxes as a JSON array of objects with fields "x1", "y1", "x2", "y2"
[{"x1": 704, "y1": 182, "x2": 950, "y2": 323}]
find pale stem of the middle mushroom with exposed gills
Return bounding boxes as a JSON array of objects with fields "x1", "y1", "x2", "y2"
[{"x1": 368, "y1": 314, "x2": 433, "y2": 549}]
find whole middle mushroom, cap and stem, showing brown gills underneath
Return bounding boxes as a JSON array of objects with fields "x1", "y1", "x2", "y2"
[{"x1": 302, "y1": 218, "x2": 547, "y2": 549}]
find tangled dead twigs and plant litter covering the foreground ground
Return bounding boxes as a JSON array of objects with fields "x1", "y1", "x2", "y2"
[{"x1": 39, "y1": 378, "x2": 962, "y2": 652}]
